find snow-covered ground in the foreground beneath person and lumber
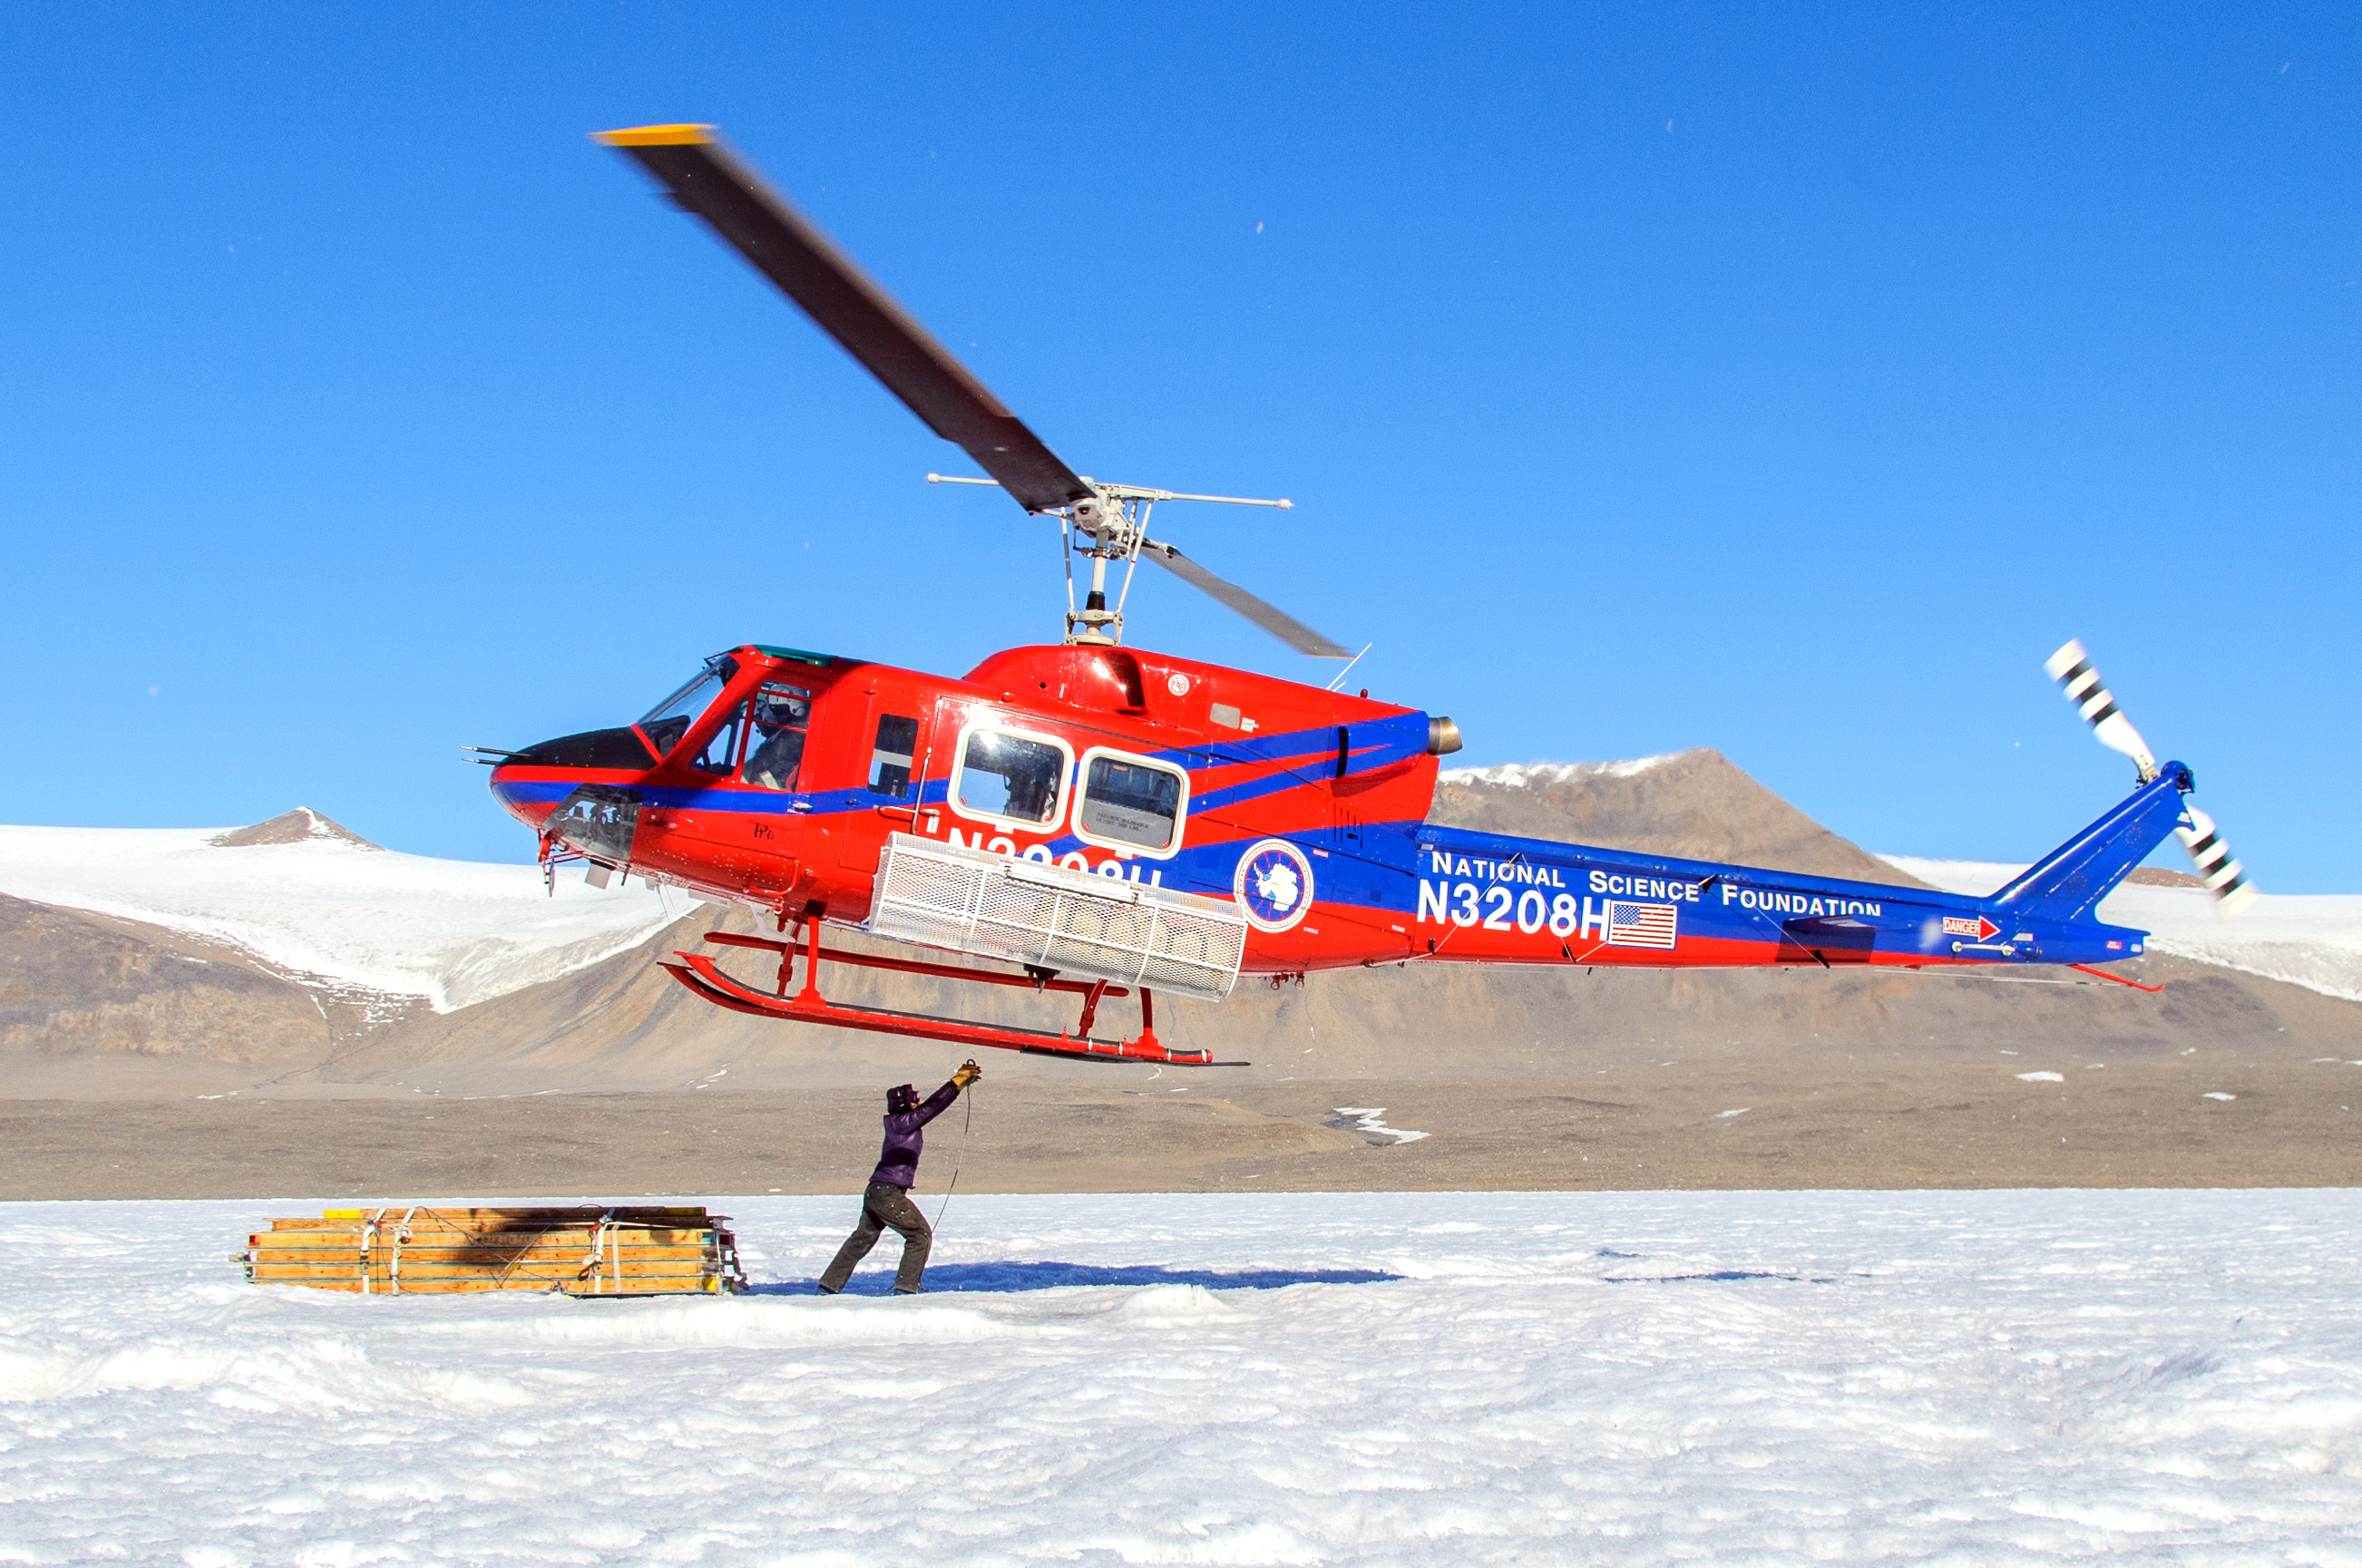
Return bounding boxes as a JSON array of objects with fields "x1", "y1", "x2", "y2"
[{"x1": 0, "y1": 1193, "x2": 2362, "y2": 1568}]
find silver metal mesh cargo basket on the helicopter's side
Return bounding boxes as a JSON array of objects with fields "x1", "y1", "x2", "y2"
[{"x1": 864, "y1": 833, "x2": 1247, "y2": 1001}]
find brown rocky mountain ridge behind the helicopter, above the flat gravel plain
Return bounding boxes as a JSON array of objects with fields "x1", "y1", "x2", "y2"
[{"x1": 0, "y1": 751, "x2": 2362, "y2": 1096}]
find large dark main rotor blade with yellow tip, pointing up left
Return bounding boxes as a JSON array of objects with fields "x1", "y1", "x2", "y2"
[{"x1": 593, "y1": 125, "x2": 1091, "y2": 512}]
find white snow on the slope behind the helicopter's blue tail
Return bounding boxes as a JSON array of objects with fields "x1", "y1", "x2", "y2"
[{"x1": 1880, "y1": 855, "x2": 2362, "y2": 1001}]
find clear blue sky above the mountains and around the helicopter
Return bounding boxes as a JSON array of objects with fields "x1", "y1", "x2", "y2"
[{"x1": 0, "y1": 5, "x2": 2362, "y2": 892}]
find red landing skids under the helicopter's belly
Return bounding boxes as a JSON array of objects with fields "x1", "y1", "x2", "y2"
[{"x1": 664, "y1": 919, "x2": 1214, "y2": 1067}]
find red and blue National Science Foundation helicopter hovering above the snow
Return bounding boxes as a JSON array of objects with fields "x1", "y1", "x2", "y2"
[{"x1": 470, "y1": 125, "x2": 2256, "y2": 1065}]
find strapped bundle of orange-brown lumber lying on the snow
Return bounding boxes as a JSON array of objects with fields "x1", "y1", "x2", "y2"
[{"x1": 241, "y1": 1204, "x2": 747, "y2": 1297}]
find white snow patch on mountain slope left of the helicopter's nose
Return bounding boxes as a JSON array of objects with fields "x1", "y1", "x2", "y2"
[{"x1": 0, "y1": 813, "x2": 692, "y2": 1013}]
